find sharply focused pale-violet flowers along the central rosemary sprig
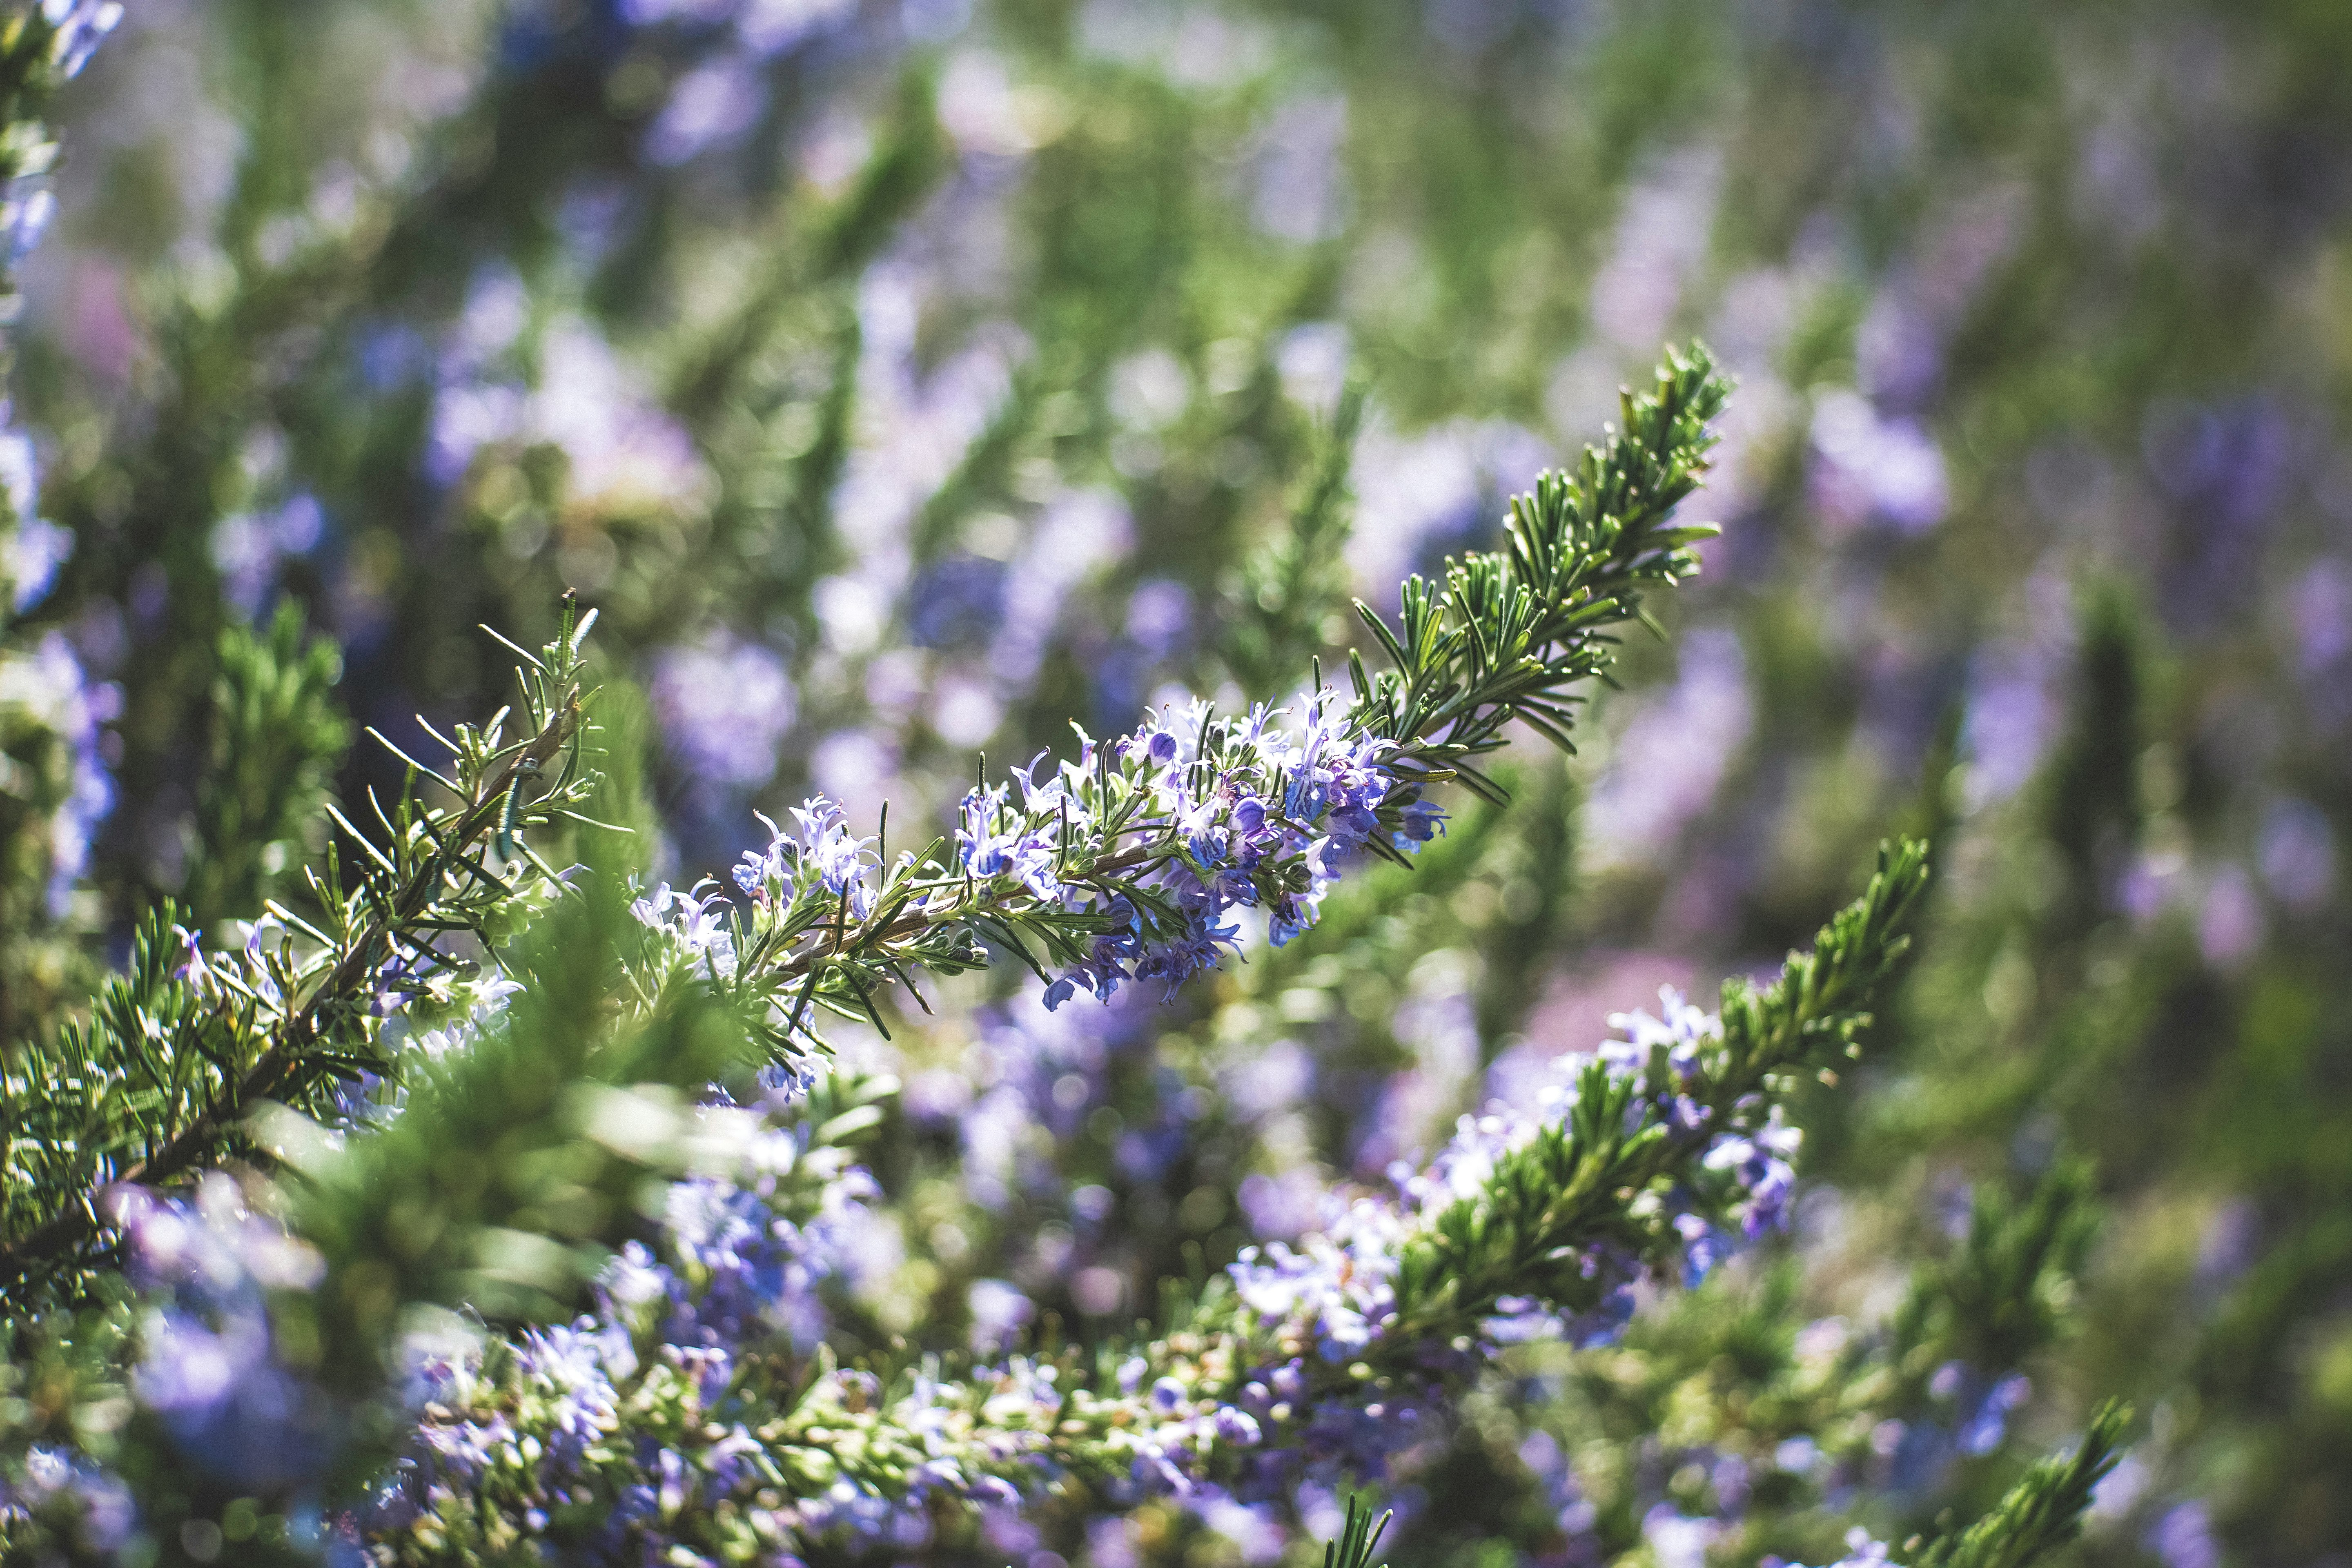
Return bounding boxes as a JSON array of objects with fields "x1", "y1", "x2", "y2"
[{"x1": 696, "y1": 691, "x2": 1444, "y2": 1044}]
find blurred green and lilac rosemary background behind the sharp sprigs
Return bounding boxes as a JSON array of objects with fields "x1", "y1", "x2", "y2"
[{"x1": 0, "y1": 0, "x2": 2352, "y2": 1568}]
